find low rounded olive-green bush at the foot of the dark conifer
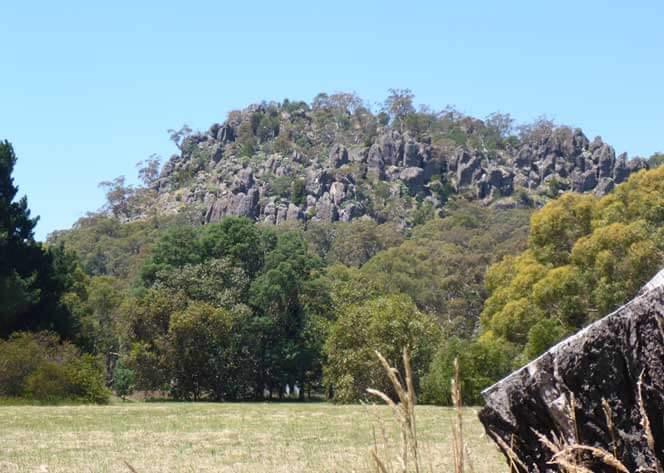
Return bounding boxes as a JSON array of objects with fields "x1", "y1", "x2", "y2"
[{"x1": 0, "y1": 332, "x2": 108, "y2": 404}]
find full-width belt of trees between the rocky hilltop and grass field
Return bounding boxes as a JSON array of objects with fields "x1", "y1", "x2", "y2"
[{"x1": 0, "y1": 138, "x2": 664, "y2": 404}]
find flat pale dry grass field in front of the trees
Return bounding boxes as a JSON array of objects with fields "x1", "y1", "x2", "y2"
[{"x1": 0, "y1": 403, "x2": 506, "y2": 473}]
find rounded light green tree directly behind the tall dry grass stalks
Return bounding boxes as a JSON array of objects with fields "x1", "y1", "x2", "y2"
[{"x1": 325, "y1": 295, "x2": 439, "y2": 402}]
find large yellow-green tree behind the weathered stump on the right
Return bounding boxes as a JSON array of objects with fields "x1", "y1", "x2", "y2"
[{"x1": 480, "y1": 167, "x2": 664, "y2": 364}]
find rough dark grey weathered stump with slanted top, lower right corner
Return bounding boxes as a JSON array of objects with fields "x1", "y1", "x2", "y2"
[{"x1": 479, "y1": 271, "x2": 664, "y2": 473}]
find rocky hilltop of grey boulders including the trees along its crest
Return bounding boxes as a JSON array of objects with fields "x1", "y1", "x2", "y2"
[{"x1": 129, "y1": 91, "x2": 647, "y2": 224}]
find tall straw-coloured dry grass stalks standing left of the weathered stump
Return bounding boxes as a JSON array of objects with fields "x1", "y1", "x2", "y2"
[{"x1": 367, "y1": 350, "x2": 475, "y2": 473}]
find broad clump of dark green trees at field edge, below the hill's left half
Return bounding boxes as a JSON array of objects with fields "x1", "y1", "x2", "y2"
[{"x1": 123, "y1": 218, "x2": 330, "y2": 400}]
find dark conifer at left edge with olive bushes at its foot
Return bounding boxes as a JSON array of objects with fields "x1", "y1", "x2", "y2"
[{"x1": 0, "y1": 141, "x2": 108, "y2": 402}]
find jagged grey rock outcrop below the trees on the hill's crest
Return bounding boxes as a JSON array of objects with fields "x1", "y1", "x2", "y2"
[{"x1": 153, "y1": 105, "x2": 647, "y2": 227}]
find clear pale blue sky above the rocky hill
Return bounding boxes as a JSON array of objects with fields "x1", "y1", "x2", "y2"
[{"x1": 0, "y1": 0, "x2": 664, "y2": 239}]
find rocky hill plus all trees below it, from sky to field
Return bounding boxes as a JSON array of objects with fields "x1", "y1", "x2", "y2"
[{"x1": 0, "y1": 91, "x2": 664, "y2": 404}]
